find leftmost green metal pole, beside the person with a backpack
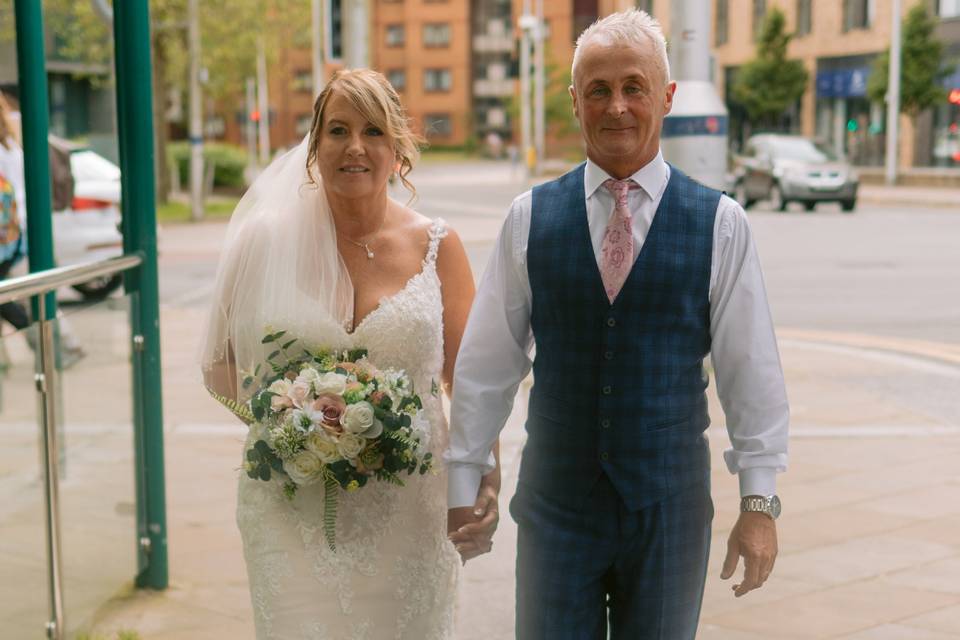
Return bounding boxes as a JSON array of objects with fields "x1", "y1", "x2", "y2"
[{"x1": 15, "y1": 0, "x2": 57, "y2": 320}]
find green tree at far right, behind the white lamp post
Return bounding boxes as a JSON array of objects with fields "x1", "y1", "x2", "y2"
[{"x1": 867, "y1": 3, "x2": 954, "y2": 118}]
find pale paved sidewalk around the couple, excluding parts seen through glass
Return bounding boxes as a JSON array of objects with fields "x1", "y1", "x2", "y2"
[{"x1": 56, "y1": 309, "x2": 960, "y2": 640}]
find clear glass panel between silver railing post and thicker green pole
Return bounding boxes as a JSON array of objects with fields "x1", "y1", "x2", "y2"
[{"x1": 57, "y1": 296, "x2": 137, "y2": 637}]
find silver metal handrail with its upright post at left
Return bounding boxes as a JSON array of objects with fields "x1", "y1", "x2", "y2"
[{"x1": 0, "y1": 254, "x2": 143, "y2": 640}]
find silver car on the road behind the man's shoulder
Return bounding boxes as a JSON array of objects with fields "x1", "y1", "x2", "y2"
[{"x1": 733, "y1": 133, "x2": 860, "y2": 211}]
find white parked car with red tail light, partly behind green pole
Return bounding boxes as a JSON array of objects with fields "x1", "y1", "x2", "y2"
[{"x1": 53, "y1": 147, "x2": 123, "y2": 300}]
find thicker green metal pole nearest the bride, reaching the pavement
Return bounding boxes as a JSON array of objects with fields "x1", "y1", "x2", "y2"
[{"x1": 113, "y1": 0, "x2": 168, "y2": 589}]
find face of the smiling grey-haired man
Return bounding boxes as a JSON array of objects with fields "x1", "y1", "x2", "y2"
[{"x1": 570, "y1": 40, "x2": 676, "y2": 179}]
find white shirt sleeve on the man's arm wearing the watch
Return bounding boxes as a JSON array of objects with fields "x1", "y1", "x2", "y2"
[{"x1": 710, "y1": 196, "x2": 790, "y2": 496}]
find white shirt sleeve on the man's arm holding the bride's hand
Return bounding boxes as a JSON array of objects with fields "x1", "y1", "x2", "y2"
[{"x1": 444, "y1": 192, "x2": 533, "y2": 508}]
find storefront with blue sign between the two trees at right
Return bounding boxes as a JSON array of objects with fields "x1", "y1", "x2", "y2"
[{"x1": 816, "y1": 55, "x2": 885, "y2": 166}]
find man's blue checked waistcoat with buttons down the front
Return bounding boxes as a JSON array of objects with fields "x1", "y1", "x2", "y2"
[{"x1": 520, "y1": 164, "x2": 720, "y2": 510}]
